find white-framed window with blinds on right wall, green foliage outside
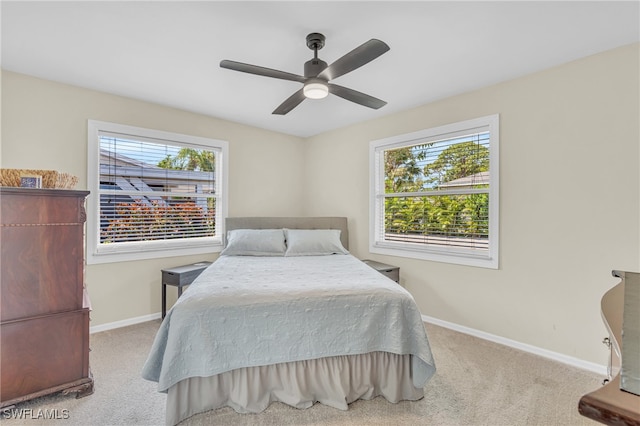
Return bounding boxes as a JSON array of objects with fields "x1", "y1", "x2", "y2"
[{"x1": 369, "y1": 115, "x2": 499, "y2": 268}]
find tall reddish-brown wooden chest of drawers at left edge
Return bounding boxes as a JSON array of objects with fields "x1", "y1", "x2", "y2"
[{"x1": 0, "y1": 187, "x2": 93, "y2": 407}]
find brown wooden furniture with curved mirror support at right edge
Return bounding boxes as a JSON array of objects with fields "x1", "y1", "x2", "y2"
[{"x1": 578, "y1": 271, "x2": 640, "y2": 426}]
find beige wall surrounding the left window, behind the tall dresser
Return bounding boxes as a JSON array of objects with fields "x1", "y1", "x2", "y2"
[{"x1": 0, "y1": 71, "x2": 304, "y2": 327}]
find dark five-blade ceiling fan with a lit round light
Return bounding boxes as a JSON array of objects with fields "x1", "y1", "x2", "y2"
[{"x1": 220, "y1": 33, "x2": 389, "y2": 115}]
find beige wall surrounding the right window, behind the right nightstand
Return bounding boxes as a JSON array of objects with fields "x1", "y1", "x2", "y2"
[{"x1": 305, "y1": 44, "x2": 640, "y2": 365}]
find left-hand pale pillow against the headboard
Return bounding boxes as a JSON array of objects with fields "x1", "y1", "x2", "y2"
[{"x1": 220, "y1": 229, "x2": 287, "y2": 256}]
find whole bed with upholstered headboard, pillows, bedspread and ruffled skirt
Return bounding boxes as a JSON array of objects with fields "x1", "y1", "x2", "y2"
[{"x1": 142, "y1": 217, "x2": 435, "y2": 425}]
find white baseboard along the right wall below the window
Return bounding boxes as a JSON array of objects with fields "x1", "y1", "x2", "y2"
[{"x1": 422, "y1": 315, "x2": 607, "y2": 376}]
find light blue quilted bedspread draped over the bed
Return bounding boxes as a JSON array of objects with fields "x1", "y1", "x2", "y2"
[{"x1": 142, "y1": 255, "x2": 435, "y2": 392}]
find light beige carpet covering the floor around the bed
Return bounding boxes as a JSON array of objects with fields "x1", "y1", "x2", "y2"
[{"x1": 0, "y1": 320, "x2": 603, "y2": 426}]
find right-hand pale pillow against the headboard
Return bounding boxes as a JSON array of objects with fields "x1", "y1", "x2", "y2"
[{"x1": 284, "y1": 229, "x2": 349, "y2": 256}]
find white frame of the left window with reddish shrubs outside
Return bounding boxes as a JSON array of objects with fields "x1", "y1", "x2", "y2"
[{"x1": 86, "y1": 120, "x2": 229, "y2": 264}]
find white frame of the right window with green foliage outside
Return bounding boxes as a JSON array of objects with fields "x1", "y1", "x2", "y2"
[{"x1": 369, "y1": 114, "x2": 500, "y2": 269}]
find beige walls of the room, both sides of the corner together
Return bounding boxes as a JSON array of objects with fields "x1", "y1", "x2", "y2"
[{"x1": 0, "y1": 41, "x2": 640, "y2": 364}]
